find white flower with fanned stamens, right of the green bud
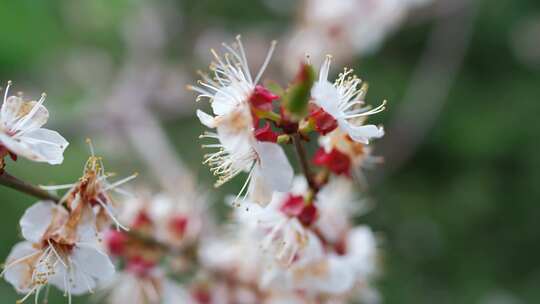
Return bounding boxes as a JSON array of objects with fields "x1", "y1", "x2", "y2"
[{"x1": 311, "y1": 56, "x2": 386, "y2": 144}]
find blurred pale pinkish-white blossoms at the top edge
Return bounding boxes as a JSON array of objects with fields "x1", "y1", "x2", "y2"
[{"x1": 285, "y1": 0, "x2": 431, "y2": 71}]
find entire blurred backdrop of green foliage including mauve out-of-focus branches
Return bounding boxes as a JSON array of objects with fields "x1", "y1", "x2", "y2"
[{"x1": 0, "y1": 0, "x2": 540, "y2": 304}]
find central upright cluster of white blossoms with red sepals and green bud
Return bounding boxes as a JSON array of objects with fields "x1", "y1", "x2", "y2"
[{"x1": 191, "y1": 37, "x2": 385, "y2": 303}]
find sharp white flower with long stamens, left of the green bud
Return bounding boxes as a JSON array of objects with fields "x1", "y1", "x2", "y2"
[{"x1": 190, "y1": 37, "x2": 293, "y2": 203}]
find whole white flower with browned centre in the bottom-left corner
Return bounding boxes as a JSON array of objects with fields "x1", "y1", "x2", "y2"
[{"x1": 3, "y1": 201, "x2": 114, "y2": 303}]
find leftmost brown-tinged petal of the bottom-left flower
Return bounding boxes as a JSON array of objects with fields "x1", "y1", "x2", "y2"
[{"x1": 4, "y1": 242, "x2": 40, "y2": 293}]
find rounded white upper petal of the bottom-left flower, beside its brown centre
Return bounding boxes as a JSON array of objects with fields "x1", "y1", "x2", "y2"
[{"x1": 19, "y1": 201, "x2": 67, "y2": 243}]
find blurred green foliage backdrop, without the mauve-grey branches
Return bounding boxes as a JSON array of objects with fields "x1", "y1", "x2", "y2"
[{"x1": 0, "y1": 0, "x2": 540, "y2": 304}]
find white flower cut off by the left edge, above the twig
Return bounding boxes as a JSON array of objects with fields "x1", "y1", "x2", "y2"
[{"x1": 0, "y1": 82, "x2": 68, "y2": 165}]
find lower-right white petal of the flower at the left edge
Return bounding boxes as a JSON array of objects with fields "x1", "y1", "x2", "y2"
[{"x1": 20, "y1": 129, "x2": 69, "y2": 165}]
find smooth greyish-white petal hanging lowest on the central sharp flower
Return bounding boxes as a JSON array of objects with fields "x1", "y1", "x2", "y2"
[{"x1": 255, "y1": 142, "x2": 294, "y2": 192}]
